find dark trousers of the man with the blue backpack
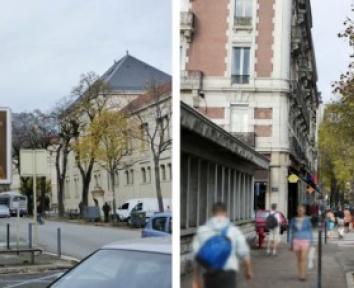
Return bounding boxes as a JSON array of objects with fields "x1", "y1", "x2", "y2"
[{"x1": 204, "y1": 271, "x2": 236, "y2": 288}]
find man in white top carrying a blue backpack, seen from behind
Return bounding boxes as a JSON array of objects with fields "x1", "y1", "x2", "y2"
[{"x1": 193, "y1": 203, "x2": 252, "y2": 288}]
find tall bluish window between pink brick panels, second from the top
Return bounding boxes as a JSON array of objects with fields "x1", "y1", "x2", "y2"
[{"x1": 231, "y1": 47, "x2": 251, "y2": 84}]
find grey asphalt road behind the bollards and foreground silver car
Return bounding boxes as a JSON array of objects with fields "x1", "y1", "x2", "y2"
[{"x1": 0, "y1": 218, "x2": 141, "y2": 259}]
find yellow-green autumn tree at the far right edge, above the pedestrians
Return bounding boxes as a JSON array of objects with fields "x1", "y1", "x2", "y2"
[{"x1": 319, "y1": 9, "x2": 354, "y2": 205}]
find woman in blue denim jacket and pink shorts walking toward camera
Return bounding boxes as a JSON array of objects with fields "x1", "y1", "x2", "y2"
[{"x1": 289, "y1": 205, "x2": 313, "y2": 281}]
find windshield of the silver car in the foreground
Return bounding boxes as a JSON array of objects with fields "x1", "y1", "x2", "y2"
[{"x1": 50, "y1": 249, "x2": 171, "y2": 288}]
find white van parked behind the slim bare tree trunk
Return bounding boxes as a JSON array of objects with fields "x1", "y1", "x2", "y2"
[{"x1": 117, "y1": 198, "x2": 171, "y2": 221}]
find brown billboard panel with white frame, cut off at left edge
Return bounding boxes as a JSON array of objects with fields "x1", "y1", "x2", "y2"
[{"x1": 0, "y1": 108, "x2": 11, "y2": 184}]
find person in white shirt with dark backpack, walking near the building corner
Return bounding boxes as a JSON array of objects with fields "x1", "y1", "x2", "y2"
[{"x1": 266, "y1": 203, "x2": 281, "y2": 256}]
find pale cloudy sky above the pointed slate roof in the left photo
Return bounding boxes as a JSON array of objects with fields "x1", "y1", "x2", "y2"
[{"x1": 0, "y1": 0, "x2": 172, "y2": 112}]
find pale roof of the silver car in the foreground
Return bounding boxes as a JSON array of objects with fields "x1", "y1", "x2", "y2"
[{"x1": 102, "y1": 236, "x2": 172, "y2": 254}]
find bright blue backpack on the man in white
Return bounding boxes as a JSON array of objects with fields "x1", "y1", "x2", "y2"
[{"x1": 196, "y1": 226, "x2": 232, "y2": 270}]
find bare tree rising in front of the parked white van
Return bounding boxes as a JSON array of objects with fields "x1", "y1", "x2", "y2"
[{"x1": 123, "y1": 83, "x2": 172, "y2": 212}]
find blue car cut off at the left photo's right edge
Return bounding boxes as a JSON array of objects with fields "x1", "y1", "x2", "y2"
[{"x1": 141, "y1": 212, "x2": 172, "y2": 238}]
